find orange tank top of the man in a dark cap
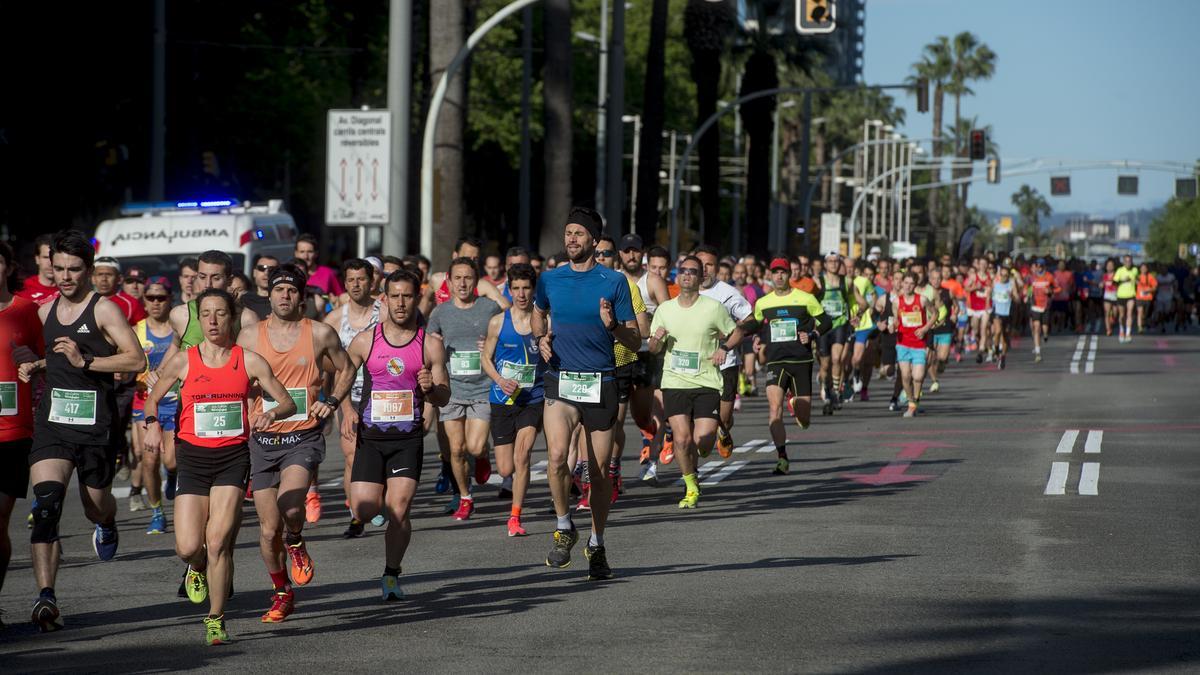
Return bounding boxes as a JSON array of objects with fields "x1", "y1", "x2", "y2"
[{"x1": 252, "y1": 318, "x2": 322, "y2": 434}]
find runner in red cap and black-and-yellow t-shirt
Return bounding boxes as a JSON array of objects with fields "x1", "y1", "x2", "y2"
[{"x1": 754, "y1": 258, "x2": 833, "y2": 476}]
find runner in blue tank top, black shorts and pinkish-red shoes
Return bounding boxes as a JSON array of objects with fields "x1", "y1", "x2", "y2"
[{"x1": 481, "y1": 263, "x2": 546, "y2": 537}]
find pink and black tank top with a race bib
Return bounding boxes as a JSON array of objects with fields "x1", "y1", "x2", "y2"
[{"x1": 359, "y1": 323, "x2": 425, "y2": 440}]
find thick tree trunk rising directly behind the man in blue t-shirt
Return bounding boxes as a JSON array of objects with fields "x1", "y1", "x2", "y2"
[{"x1": 540, "y1": 0, "x2": 571, "y2": 251}]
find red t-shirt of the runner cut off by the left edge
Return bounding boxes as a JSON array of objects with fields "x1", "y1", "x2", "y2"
[{"x1": 0, "y1": 295, "x2": 46, "y2": 443}]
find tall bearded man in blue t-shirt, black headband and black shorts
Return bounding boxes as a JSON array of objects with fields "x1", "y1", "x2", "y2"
[{"x1": 533, "y1": 207, "x2": 641, "y2": 580}]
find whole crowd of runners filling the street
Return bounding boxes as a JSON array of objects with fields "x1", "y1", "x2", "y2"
[{"x1": 0, "y1": 213, "x2": 1200, "y2": 644}]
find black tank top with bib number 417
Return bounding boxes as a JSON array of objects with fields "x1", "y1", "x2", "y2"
[{"x1": 34, "y1": 293, "x2": 116, "y2": 446}]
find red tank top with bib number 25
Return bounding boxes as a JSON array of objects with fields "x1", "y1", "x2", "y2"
[{"x1": 176, "y1": 345, "x2": 250, "y2": 448}]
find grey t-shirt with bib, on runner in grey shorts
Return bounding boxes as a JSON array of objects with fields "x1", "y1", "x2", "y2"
[{"x1": 426, "y1": 298, "x2": 503, "y2": 401}]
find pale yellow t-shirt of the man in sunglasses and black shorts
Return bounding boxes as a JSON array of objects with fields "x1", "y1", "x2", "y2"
[{"x1": 650, "y1": 295, "x2": 737, "y2": 390}]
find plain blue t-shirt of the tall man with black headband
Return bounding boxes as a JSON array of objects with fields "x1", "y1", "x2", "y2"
[{"x1": 534, "y1": 264, "x2": 636, "y2": 372}]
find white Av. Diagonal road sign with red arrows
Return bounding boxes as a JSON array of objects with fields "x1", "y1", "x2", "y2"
[{"x1": 325, "y1": 109, "x2": 391, "y2": 225}]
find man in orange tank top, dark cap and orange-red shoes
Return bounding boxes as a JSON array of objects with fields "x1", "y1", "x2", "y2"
[{"x1": 238, "y1": 264, "x2": 354, "y2": 623}]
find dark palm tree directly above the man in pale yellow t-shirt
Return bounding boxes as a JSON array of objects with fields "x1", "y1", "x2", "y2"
[{"x1": 686, "y1": 0, "x2": 740, "y2": 241}]
